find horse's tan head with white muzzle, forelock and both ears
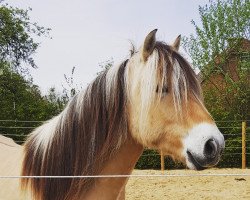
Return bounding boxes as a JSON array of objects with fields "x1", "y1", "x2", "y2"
[{"x1": 126, "y1": 30, "x2": 225, "y2": 169}]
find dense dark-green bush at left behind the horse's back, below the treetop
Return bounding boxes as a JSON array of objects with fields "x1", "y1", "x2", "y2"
[{"x1": 0, "y1": 66, "x2": 62, "y2": 141}]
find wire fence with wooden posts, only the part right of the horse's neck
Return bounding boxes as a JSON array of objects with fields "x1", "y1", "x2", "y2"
[{"x1": 136, "y1": 120, "x2": 250, "y2": 170}]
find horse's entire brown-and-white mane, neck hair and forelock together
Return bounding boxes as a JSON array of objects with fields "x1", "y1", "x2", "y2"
[{"x1": 21, "y1": 42, "x2": 201, "y2": 200}]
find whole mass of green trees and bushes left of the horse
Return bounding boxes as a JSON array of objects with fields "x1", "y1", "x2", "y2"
[{"x1": 0, "y1": 1, "x2": 57, "y2": 144}]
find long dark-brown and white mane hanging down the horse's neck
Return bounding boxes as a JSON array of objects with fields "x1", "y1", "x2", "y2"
[{"x1": 22, "y1": 61, "x2": 128, "y2": 200}]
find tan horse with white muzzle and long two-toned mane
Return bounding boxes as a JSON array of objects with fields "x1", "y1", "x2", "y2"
[{"x1": 0, "y1": 29, "x2": 225, "y2": 200}]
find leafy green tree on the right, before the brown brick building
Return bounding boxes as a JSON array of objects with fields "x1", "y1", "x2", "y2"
[{"x1": 183, "y1": 0, "x2": 250, "y2": 167}]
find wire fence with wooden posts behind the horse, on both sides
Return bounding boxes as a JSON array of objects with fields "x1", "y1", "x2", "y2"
[{"x1": 0, "y1": 120, "x2": 250, "y2": 171}]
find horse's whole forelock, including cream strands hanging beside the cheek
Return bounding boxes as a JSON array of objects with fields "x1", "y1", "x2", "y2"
[{"x1": 126, "y1": 41, "x2": 202, "y2": 134}]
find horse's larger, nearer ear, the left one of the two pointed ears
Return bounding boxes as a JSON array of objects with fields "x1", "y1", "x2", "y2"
[{"x1": 142, "y1": 29, "x2": 157, "y2": 62}]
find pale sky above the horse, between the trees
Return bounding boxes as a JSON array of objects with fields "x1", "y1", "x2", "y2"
[{"x1": 5, "y1": 0, "x2": 208, "y2": 93}]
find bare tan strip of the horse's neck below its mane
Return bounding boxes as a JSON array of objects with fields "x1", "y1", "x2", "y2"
[{"x1": 84, "y1": 137, "x2": 143, "y2": 200}]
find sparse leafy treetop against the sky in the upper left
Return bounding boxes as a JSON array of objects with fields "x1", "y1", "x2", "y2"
[{"x1": 0, "y1": 1, "x2": 50, "y2": 73}]
